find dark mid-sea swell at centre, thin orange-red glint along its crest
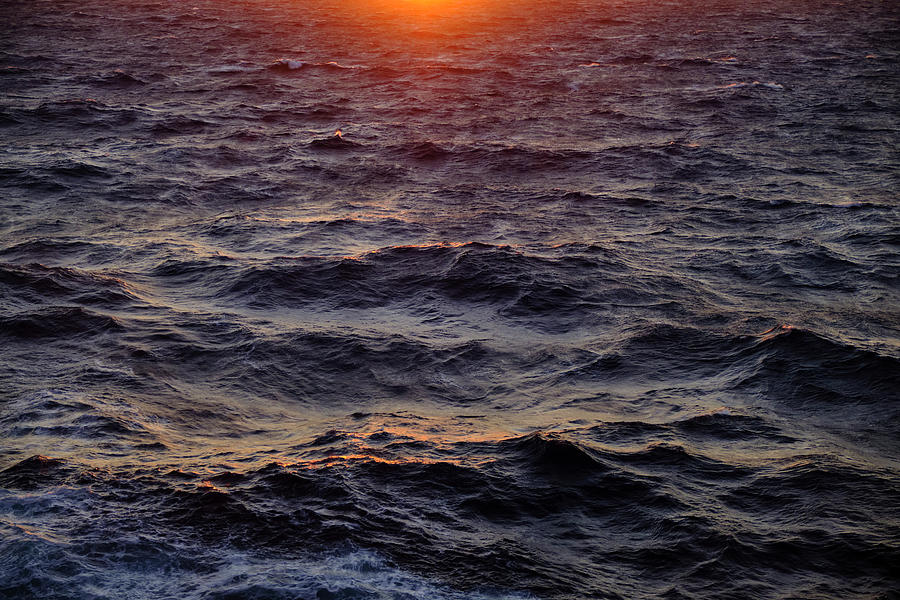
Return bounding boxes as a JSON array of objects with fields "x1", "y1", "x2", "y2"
[{"x1": 217, "y1": 242, "x2": 628, "y2": 316}]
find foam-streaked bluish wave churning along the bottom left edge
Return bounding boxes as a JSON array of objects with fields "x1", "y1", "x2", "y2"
[{"x1": 0, "y1": 510, "x2": 533, "y2": 600}]
